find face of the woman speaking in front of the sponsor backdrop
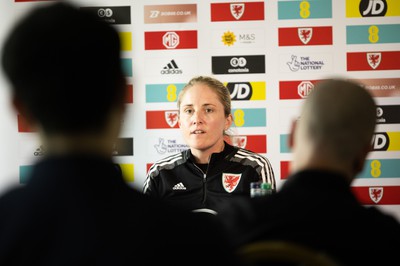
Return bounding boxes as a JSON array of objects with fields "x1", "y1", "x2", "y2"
[{"x1": 179, "y1": 83, "x2": 232, "y2": 154}]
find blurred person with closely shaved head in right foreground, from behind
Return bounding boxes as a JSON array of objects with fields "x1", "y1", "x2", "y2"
[{"x1": 220, "y1": 79, "x2": 400, "y2": 265}]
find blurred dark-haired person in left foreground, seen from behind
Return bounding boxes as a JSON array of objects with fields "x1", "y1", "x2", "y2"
[{"x1": 0, "y1": 3, "x2": 239, "y2": 265}]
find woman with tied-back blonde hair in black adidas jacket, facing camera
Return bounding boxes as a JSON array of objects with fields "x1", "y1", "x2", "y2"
[{"x1": 143, "y1": 76, "x2": 276, "y2": 214}]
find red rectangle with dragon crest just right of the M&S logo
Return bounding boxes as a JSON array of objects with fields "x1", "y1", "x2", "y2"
[{"x1": 278, "y1": 26, "x2": 332, "y2": 46}]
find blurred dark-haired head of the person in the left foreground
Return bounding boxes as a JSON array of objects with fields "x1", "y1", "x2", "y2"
[{"x1": 2, "y1": 3, "x2": 126, "y2": 155}]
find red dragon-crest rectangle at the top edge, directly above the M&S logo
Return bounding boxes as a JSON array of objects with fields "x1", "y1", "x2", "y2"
[{"x1": 211, "y1": 2, "x2": 264, "y2": 21}]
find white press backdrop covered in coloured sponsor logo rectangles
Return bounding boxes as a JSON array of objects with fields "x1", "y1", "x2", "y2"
[{"x1": 0, "y1": 0, "x2": 400, "y2": 219}]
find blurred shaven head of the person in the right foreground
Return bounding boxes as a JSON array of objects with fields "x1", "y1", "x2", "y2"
[{"x1": 289, "y1": 79, "x2": 376, "y2": 180}]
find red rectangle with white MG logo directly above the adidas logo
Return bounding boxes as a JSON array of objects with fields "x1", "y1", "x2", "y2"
[{"x1": 144, "y1": 30, "x2": 197, "y2": 50}]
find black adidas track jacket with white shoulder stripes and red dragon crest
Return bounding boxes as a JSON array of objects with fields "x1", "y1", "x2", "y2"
[{"x1": 143, "y1": 142, "x2": 276, "y2": 214}]
